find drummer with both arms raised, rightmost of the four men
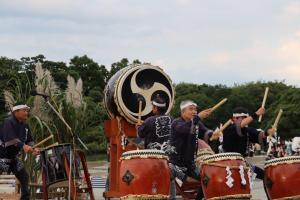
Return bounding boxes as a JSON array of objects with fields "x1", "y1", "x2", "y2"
[{"x1": 223, "y1": 107, "x2": 275, "y2": 180}]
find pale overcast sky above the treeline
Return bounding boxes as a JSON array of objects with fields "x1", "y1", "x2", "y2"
[{"x1": 0, "y1": 0, "x2": 300, "y2": 87}]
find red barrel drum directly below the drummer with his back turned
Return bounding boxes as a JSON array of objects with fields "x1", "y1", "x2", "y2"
[{"x1": 119, "y1": 149, "x2": 170, "y2": 199}]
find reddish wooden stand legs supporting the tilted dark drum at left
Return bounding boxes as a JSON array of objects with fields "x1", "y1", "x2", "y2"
[{"x1": 42, "y1": 150, "x2": 95, "y2": 200}]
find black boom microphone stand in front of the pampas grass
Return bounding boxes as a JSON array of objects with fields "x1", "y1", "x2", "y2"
[{"x1": 40, "y1": 95, "x2": 88, "y2": 200}]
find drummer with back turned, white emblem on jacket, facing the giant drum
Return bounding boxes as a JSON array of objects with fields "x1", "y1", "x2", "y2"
[{"x1": 138, "y1": 95, "x2": 172, "y2": 154}]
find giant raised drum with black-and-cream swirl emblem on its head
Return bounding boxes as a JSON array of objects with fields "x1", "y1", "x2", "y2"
[{"x1": 104, "y1": 64, "x2": 175, "y2": 124}]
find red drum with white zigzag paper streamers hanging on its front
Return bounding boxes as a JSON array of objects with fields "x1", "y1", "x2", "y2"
[{"x1": 201, "y1": 153, "x2": 251, "y2": 200}]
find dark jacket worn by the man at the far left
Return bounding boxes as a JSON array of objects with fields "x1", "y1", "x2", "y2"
[{"x1": 0, "y1": 116, "x2": 33, "y2": 159}]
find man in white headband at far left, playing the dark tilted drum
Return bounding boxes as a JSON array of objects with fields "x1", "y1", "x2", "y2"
[{"x1": 0, "y1": 103, "x2": 39, "y2": 200}]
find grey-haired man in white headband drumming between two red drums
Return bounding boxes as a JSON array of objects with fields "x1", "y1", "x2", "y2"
[{"x1": 169, "y1": 100, "x2": 213, "y2": 199}]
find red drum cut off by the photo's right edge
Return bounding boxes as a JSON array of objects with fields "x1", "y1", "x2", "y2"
[{"x1": 264, "y1": 156, "x2": 300, "y2": 199}]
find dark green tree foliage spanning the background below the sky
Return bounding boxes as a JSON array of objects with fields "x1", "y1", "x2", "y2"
[{"x1": 0, "y1": 55, "x2": 300, "y2": 159}]
